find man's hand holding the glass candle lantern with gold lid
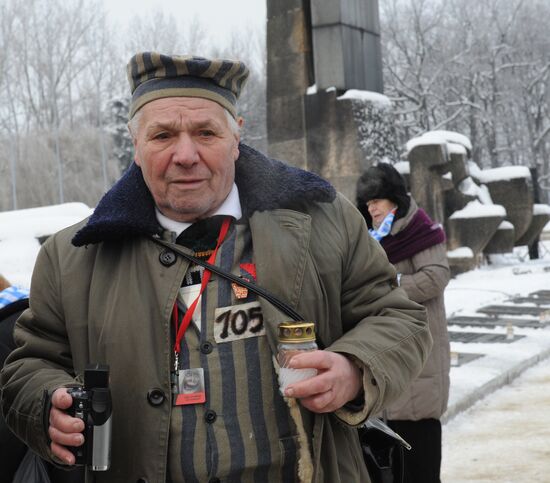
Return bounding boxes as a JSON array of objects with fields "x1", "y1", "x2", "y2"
[{"x1": 285, "y1": 350, "x2": 363, "y2": 413}]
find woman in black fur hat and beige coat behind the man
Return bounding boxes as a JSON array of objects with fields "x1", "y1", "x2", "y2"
[{"x1": 357, "y1": 163, "x2": 450, "y2": 483}]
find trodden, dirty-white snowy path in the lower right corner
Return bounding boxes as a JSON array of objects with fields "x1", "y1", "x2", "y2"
[{"x1": 441, "y1": 359, "x2": 550, "y2": 483}]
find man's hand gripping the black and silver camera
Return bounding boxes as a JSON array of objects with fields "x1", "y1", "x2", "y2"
[{"x1": 48, "y1": 388, "x2": 84, "y2": 465}]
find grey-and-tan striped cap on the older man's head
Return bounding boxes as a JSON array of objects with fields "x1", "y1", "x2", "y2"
[{"x1": 127, "y1": 52, "x2": 249, "y2": 119}]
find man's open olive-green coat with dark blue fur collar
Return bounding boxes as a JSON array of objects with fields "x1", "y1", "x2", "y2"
[{"x1": 2, "y1": 145, "x2": 431, "y2": 483}]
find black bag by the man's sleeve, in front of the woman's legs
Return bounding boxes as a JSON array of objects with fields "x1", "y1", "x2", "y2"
[{"x1": 358, "y1": 419, "x2": 411, "y2": 483}]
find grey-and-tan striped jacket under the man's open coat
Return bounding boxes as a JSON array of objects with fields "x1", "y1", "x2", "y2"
[{"x1": 168, "y1": 223, "x2": 297, "y2": 483}]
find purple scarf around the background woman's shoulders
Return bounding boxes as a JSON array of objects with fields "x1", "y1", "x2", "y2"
[{"x1": 380, "y1": 208, "x2": 445, "y2": 263}]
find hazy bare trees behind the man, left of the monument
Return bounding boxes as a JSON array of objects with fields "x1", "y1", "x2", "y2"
[{"x1": 0, "y1": 0, "x2": 265, "y2": 210}]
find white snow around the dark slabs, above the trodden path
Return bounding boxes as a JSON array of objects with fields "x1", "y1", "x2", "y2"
[{"x1": 445, "y1": 246, "x2": 550, "y2": 417}]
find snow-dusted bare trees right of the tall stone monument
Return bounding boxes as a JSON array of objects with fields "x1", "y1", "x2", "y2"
[{"x1": 381, "y1": 0, "x2": 550, "y2": 200}]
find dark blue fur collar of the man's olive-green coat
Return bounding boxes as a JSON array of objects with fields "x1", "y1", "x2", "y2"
[{"x1": 72, "y1": 144, "x2": 336, "y2": 246}]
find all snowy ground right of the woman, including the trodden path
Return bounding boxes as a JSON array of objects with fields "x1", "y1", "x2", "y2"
[{"x1": 441, "y1": 241, "x2": 550, "y2": 483}]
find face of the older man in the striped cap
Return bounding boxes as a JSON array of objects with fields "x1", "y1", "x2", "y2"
[{"x1": 133, "y1": 97, "x2": 239, "y2": 222}]
